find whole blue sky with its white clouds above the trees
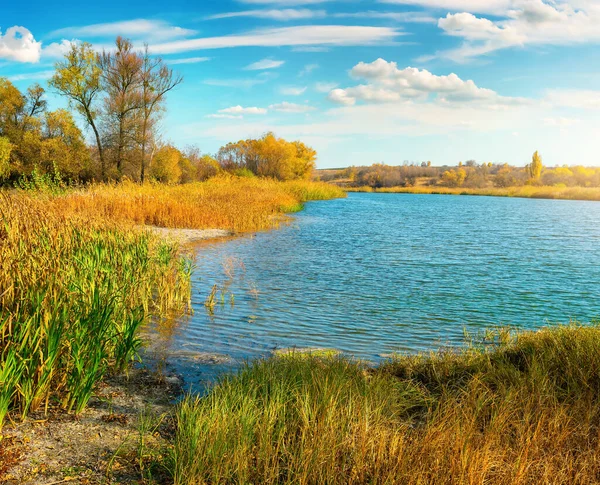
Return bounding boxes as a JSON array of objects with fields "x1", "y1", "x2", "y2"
[{"x1": 0, "y1": 0, "x2": 600, "y2": 168}]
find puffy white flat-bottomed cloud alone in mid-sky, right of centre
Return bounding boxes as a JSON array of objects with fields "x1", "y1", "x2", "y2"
[{"x1": 329, "y1": 59, "x2": 524, "y2": 106}]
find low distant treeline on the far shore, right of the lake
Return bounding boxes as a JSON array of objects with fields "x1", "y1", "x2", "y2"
[{"x1": 318, "y1": 152, "x2": 600, "y2": 189}]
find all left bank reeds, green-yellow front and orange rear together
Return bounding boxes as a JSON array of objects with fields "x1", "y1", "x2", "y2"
[{"x1": 0, "y1": 177, "x2": 344, "y2": 428}]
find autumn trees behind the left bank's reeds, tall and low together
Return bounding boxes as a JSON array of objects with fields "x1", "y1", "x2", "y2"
[{"x1": 0, "y1": 37, "x2": 316, "y2": 185}]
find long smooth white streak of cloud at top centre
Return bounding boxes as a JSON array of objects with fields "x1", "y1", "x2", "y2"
[{"x1": 152, "y1": 25, "x2": 403, "y2": 54}]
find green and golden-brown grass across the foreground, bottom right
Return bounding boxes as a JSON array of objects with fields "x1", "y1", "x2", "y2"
[{"x1": 172, "y1": 325, "x2": 600, "y2": 485}]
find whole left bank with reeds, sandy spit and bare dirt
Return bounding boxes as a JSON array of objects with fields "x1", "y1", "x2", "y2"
[{"x1": 0, "y1": 177, "x2": 344, "y2": 484}]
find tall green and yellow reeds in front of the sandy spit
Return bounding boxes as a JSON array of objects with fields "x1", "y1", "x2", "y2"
[{"x1": 0, "y1": 193, "x2": 191, "y2": 426}]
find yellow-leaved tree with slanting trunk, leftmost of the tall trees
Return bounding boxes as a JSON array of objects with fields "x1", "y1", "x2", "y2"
[{"x1": 49, "y1": 42, "x2": 106, "y2": 179}]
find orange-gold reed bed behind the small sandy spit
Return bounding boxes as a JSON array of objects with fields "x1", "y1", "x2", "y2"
[{"x1": 45, "y1": 176, "x2": 345, "y2": 232}]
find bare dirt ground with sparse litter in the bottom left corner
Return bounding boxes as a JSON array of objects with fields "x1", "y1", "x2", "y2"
[{"x1": 0, "y1": 369, "x2": 181, "y2": 485}]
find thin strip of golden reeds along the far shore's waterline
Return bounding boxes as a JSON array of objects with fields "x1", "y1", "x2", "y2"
[{"x1": 344, "y1": 185, "x2": 600, "y2": 201}]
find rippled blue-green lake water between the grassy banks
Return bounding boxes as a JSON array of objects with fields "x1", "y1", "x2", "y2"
[{"x1": 156, "y1": 194, "x2": 600, "y2": 386}]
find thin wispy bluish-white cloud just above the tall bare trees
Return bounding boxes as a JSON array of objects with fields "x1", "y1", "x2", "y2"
[{"x1": 50, "y1": 19, "x2": 196, "y2": 41}]
